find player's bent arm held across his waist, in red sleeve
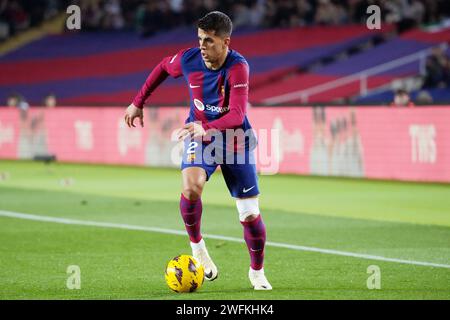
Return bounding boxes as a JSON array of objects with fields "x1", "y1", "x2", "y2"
[{"x1": 179, "y1": 63, "x2": 249, "y2": 140}]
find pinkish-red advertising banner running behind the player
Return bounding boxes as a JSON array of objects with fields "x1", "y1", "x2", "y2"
[{"x1": 0, "y1": 106, "x2": 450, "y2": 182}]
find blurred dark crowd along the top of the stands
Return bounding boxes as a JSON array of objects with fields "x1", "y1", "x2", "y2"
[{"x1": 0, "y1": 0, "x2": 450, "y2": 40}]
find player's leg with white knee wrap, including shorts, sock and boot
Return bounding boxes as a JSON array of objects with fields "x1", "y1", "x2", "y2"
[{"x1": 222, "y1": 164, "x2": 272, "y2": 290}]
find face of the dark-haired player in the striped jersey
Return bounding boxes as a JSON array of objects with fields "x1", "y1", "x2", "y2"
[{"x1": 198, "y1": 29, "x2": 230, "y2": 65}]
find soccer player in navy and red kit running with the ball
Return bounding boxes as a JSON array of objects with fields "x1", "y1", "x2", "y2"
[{"x1": 125, "y1": 11, "x2": 272, "y2": 290}]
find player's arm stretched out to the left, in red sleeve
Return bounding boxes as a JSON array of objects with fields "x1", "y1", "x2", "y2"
[{"x1": 125, "y1": 50, "x2": 186, "y2": 128}]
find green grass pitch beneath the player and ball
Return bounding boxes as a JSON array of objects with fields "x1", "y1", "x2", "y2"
[{"x1": 0, "y1": 161, "x2": 450, "y2": 299}]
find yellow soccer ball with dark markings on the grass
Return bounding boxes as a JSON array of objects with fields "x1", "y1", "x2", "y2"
[{"x1": 165, "y1": 254, "x2": 205, "y2": 292}]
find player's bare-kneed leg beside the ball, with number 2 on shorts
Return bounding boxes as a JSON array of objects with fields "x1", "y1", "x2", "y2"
[{"x1": 180, "y1": 142, "x2": 218, "y2": 281}]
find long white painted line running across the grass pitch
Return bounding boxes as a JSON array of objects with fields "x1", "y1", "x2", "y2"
[{"x1": 0, "y1": 210, "x2": 450, "y2": 269}]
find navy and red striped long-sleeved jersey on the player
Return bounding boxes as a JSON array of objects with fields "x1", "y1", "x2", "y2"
[{"x1": 133, "y1": 48, "x2": 251, "y2": 131}]
